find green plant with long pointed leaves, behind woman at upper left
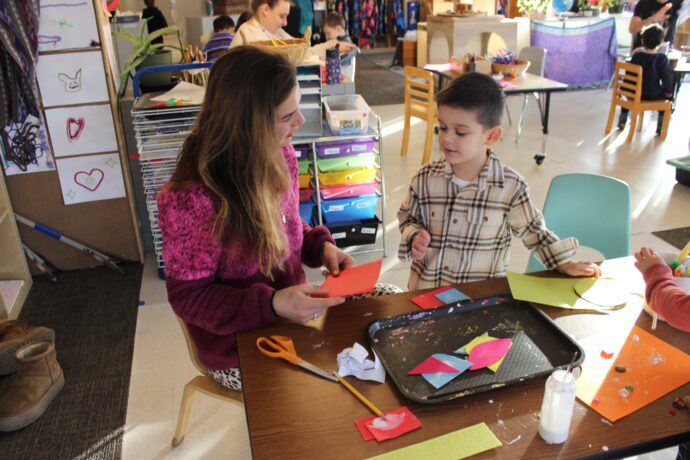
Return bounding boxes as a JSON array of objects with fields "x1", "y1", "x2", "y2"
[{"x1": 113, "y1": 19, "x2": 182, "y2": 100}]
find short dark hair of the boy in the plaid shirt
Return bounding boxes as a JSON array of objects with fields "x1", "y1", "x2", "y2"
[{"x1": 436, "y1": 72, "x2": 506, "y2": 129}]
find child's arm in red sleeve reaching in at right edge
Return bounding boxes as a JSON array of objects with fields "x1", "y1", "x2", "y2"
[{"x1": 635, "y1": 248, "x2": 690, "y2": 332}]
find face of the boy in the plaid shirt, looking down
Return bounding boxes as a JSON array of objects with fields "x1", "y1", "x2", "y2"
[{"x1": 438, "y1": 105, "x2": 501, "y2": 167}]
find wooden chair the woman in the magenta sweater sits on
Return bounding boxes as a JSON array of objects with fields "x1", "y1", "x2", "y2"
[{"x1": 172, "y1": 317, "x2": 244, "y2": 447}]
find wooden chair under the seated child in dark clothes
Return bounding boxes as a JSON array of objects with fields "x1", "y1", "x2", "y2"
[{"x1": 606, "y1": 61, "x2": 671, "y2": 142}]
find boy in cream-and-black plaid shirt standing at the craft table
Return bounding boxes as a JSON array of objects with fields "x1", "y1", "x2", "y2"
[{"x1": 398, "y1": 73, "x2": 601, "y2": 290}]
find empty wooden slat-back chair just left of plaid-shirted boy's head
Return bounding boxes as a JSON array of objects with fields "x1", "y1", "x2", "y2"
[{"x1": 400, "y1": 66, "x2": 436, "y2": 164}]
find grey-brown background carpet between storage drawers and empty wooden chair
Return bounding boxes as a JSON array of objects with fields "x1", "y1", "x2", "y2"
[{"x1": 355, "y1": 51, "x2": 405, "y2": 106}]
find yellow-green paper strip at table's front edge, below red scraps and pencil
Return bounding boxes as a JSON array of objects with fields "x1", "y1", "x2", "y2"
[{"x1": 370, "y1": 423, "x2": 502, "y2": 460}]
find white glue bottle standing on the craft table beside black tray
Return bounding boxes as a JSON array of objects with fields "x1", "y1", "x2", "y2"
[{"x1": 539, "y1": 369, "x2": 576, "y2": 444}]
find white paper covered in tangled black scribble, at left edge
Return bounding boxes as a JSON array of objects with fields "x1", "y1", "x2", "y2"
[{"x1": 0, "y1": 115, "x2": 55, "y2": 176}]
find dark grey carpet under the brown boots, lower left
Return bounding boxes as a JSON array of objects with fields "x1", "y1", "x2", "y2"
[{"x1": 0, "y1": 263, "x2": 142, "y2": 460}]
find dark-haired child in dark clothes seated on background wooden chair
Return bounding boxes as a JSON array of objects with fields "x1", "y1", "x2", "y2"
[{"x1": 618, "y1": 24, "x2": 673, "y2": 135}]
